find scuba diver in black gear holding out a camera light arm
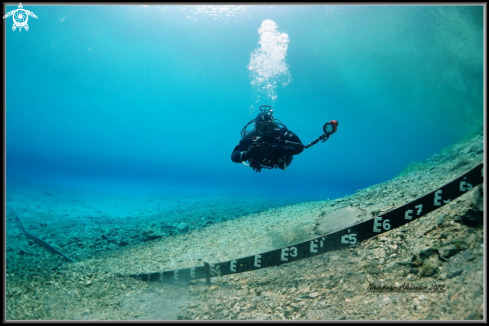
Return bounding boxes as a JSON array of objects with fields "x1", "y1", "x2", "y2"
[{"x1": 231, "y1": 105, "x2": 338, "y2": 172}]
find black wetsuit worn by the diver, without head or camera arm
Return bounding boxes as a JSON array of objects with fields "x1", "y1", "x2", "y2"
[{"x1": 231, "y1": 125, "x2": 304, "y2": 172}]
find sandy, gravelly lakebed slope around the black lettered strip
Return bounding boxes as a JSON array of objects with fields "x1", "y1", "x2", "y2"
[{"x1": 6, "y1": 131, "x2": 485, "y2": 320}]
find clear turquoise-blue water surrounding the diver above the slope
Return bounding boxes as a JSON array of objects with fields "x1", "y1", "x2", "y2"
[{"x1": 4, "y1": 5, "x2": 484, "y2": 204}]
